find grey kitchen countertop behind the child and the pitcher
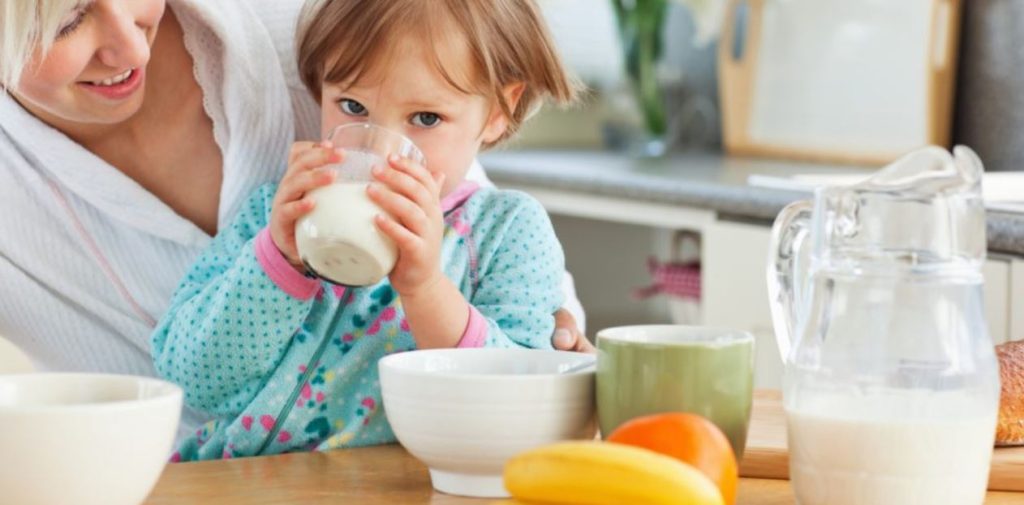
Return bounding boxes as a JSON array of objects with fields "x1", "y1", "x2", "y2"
[{"x1": 480, "y1": 151, "x2": 1024, "y2": 255}]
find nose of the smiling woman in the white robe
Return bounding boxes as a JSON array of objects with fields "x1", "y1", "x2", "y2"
[{"x1": 96, "y1": 1, "x2": 153, "y2": 70}]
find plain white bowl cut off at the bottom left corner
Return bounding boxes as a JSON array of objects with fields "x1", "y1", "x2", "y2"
[{"x1": 0, "y1": 373, "x2": 181, "y2": 505}]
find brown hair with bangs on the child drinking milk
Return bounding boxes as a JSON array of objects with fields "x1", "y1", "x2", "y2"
[{"x1": 296, "y1": 0, "x2": 579, "y2": 143}]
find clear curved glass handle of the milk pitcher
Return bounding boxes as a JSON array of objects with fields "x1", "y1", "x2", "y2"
[{"x1": 768, "y1": 200, "x2": 813, "y2": 364}]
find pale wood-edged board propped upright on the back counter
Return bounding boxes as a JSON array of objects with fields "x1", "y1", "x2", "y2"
[{"x1": 718, "y1": 0, "x2": 965, "y2": 165}]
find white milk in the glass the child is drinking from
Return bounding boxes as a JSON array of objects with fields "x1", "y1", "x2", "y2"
[{"x1": 295, "y1": 151, "x2": 398, "y2": 286}]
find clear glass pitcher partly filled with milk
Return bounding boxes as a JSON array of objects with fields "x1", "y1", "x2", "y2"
[{"x1": 768, "y1": 146, "x2": 999, "y2": 505}]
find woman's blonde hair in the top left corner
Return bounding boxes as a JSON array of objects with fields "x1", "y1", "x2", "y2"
[{"x1": 0, "y1": 0, "x2": 82, "y2": 90}]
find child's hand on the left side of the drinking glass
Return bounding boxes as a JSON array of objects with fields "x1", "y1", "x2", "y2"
[{"x1": 270, "y1": 140, "x2": 342, "y2": 271}]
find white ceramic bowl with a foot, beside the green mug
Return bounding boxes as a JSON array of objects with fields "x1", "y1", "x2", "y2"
[{"x1": 380, "y1": 349, "x2": 596, "y2": 498}]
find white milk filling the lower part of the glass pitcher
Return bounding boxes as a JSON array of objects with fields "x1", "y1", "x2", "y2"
[{"x1": 786, "y1": 392, "x2": 996, "y2": 505}]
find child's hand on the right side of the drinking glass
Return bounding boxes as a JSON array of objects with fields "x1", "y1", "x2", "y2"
[{"x1": 367, "y1": 156, "x2": 444, "y2": 297}]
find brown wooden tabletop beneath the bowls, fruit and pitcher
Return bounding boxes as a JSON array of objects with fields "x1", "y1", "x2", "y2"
[{"x1": 145, "y1": 446, "x2": 1024, "y2": 505}]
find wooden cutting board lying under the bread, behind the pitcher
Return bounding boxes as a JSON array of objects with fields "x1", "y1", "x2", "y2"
[{"x1": 739, "y1": 390, "x2": 1024, "y2": 492}]
